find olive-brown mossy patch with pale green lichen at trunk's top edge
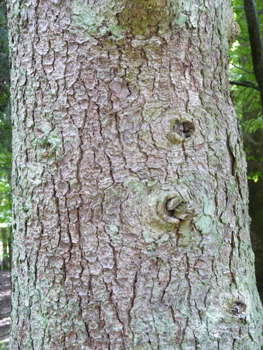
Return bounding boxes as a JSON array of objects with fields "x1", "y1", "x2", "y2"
[{"x1": 70, "y1": 0, "x2": 188, "y2": 41}]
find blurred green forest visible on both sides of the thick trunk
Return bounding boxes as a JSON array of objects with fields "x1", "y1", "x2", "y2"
[{"x1": 0, "y1": 0, "x2": 263, "y2": 301}]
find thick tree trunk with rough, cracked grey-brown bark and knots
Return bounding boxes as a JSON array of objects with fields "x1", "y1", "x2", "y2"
[{"x1": 8, "y1": 0, "x2": 263, "y2": 350}]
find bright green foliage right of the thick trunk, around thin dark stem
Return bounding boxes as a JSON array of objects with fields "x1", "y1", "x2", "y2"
[{"x1": 230, "y1": 0, "x2": 263, "y2": 189}]
